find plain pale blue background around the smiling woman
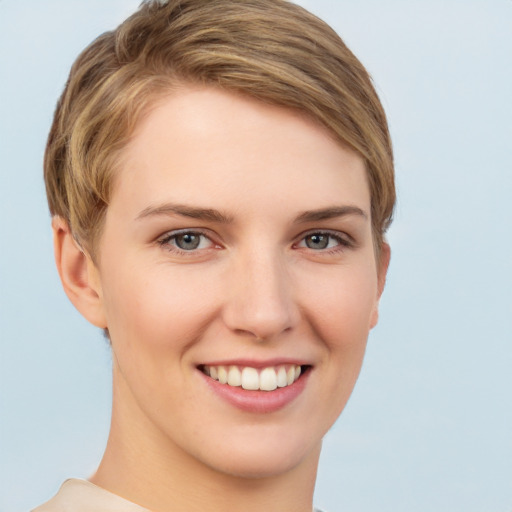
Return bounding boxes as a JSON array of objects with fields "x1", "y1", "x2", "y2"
[{"x1": 0, "y1": 0, "x2": 512, "y2": 512}]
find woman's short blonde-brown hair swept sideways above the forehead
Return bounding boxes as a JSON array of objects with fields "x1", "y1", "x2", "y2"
[{"x1": 44, "y1": 0, "x2": 395, "y2": 258}]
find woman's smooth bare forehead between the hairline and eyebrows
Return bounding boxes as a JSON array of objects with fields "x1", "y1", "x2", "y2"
[{"x1": 111, "y1": 87, "x2": 369, "y2": 216}]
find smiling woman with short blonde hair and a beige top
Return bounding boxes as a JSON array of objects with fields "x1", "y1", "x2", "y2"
[{"x1": 36, "y1": 0, "x2": 395, "y2": 512}]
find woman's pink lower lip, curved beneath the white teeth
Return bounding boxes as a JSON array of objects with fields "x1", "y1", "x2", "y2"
[{"x1": 198, "y1": 368, "x2": 311, "y2": 414}]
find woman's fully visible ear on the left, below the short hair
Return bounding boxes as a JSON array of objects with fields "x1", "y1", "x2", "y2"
[{"x1": 52, "y1": 216, "x2": 107, "y2": 328}]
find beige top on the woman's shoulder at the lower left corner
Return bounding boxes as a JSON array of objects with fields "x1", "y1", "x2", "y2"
[{"x1": 32, "y1": 478, "x2": 150, "y2": 512}]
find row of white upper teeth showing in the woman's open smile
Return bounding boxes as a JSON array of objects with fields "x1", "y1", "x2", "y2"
[{"x1": 199, "y1": 364, "x2": 310, "y2": 391}]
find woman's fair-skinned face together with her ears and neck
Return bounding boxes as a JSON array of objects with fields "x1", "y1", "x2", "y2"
[{"x1": 53, "y1": 88, "x2": 389, "y2": 512}]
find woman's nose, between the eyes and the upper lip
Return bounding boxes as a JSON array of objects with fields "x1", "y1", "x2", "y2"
[{"x1": 223, "y1": 250, "x2": 299, "y2": 340}]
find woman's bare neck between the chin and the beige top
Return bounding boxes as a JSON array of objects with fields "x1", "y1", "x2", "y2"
[{"x1": 91, "y1": 368, "x2": 320, "y2": 512}]
